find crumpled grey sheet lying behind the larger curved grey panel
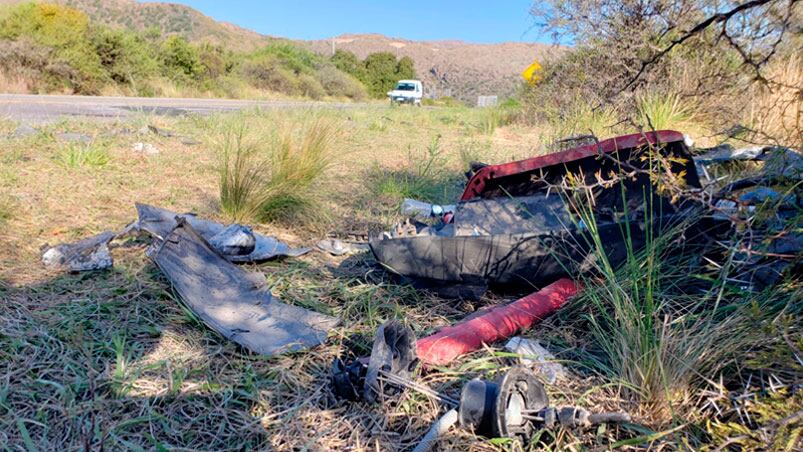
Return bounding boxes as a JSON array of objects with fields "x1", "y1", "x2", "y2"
[{"x1": 133, "y1": 204, "x2": 311, "y2": 262}]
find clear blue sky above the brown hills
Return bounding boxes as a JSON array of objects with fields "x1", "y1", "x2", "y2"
[{"x1": 144, "y1": 0, "x2": 549, "y2": 43}]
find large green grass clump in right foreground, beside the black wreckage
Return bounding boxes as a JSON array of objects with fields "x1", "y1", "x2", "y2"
[{"x1": 568, "y1": 150, "x2": 799, "y2": 426}]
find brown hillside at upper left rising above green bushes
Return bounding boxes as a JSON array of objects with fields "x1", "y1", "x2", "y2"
[{"x1": 0, "y1": 0, "x2": 269, "y2": 51}]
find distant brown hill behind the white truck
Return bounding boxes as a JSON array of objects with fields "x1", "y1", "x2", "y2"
[{"x1": 307, "y1": 34, "x2": 562, "y2": 103}]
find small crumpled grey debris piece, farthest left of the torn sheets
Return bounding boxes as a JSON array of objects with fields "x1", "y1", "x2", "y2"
[{"x1": 42, "y1": 231, "x2": 116, "y2": 272}]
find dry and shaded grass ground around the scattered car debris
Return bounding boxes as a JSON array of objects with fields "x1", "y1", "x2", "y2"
[{"x1": 0, "y1": 107, "x2": 796, "y2": 451}]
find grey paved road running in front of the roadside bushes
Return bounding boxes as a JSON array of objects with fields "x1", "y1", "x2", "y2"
[{"x1": 0, "y1": 94, "x2": 365, "y2": 123}]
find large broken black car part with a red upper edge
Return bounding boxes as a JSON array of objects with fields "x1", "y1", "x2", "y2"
[{"x1": 370, "y1": 131, "x2": 700, "y2": 296}]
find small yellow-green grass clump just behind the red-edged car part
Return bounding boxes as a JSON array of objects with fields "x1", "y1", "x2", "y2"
[{"x1": 636, "y1": 92, "x2": 700, "y2": 131}]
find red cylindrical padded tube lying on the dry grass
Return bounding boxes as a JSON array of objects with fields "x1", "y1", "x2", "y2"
[{"x1": 416, "y1": 278, "x2": 579, "y2": 365}]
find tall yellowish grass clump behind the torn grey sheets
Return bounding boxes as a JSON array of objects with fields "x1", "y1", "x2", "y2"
[{"x1": 218, "y1": 119, "x2": 339, "y2": 221}]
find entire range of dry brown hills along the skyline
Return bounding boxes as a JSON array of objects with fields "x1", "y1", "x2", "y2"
[{"x1": 0, "y1": 0, "x2": 562, "y2": 104}]
